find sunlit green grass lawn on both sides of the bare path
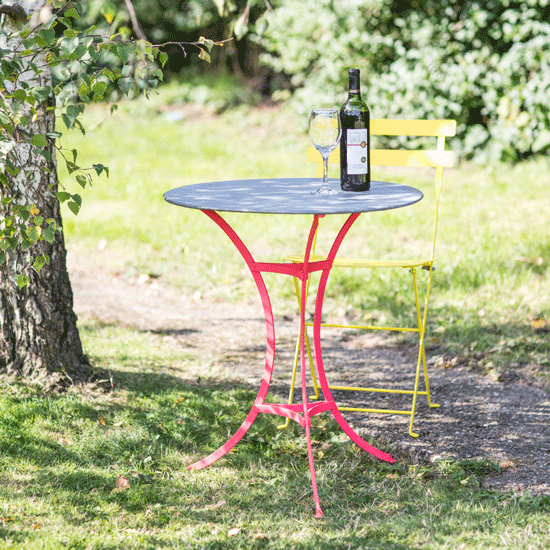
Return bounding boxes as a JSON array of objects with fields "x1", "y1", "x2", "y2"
[{"x1": 0, "y1": 90, "x2": 550, "y2": 550}]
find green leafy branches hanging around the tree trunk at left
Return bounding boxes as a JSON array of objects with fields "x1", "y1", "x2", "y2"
[{"x1": 0, "y1": 0, "x2": 223, "y2": 286}]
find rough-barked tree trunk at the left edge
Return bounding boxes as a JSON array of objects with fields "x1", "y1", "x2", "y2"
[{"x1": 0, "y1": 0, "x2": 91, "y2": 386}]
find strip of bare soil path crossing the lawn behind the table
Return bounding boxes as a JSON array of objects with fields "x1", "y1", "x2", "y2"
[{"x1": 69, "y1": 248, "x2": 550, "y2": 495}]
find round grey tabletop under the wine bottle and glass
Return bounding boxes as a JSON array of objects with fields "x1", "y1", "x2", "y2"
[{"x1": 164, "y1": 178, "x2": 423, "y2": 214}]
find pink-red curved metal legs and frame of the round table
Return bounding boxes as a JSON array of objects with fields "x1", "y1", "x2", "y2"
[{"x1": 165, "y1": 180, "x2": 422, "y2": 517}]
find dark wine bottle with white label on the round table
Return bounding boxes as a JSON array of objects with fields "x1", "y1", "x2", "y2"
[{"x1": 340, "y1": 69, "x2": 370, "y2": 191}]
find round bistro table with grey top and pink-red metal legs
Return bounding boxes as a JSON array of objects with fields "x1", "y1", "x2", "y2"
[{"x1": 164, "y1": 178, "x2": 423, "y2": 517}]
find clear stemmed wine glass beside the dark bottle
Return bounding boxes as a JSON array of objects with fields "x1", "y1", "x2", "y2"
[{"x1": 309, "y1": 109, "x2": 342, "y2": 195}]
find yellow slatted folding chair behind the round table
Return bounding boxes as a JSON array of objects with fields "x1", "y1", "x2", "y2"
[{"x1": 281, "y1": 119, "x2": 456, "y2": 437}]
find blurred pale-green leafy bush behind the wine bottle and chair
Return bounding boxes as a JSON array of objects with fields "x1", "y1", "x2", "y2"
[{"x1": 257, "y1": 0, "x2": 550, "y2": 161}]
